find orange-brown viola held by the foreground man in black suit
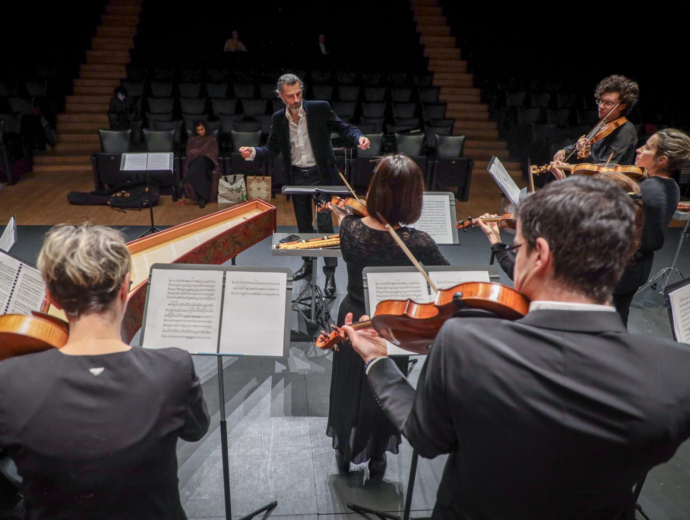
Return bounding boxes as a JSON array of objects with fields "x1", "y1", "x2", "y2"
[{"x1": 316, "y1": 282, "x2": 529, "y2": 354}]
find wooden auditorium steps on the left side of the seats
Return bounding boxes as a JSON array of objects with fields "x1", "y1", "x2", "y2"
[{"x1": 33, "y1": 0, "x2": 142, "y2": 174}]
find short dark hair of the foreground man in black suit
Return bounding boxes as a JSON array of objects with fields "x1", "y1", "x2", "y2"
[{"x1": 518, "y1": 175, "x2": 635, "y2": 303}]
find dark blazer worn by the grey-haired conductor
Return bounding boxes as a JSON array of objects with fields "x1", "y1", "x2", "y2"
[{"x1": 251, "y1": 100, "x2": 362, "y2": 184}]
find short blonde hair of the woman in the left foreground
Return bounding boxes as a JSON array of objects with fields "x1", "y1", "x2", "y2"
[{"x1": 38, "y1": 224, "x2": 132, "y2": 317}]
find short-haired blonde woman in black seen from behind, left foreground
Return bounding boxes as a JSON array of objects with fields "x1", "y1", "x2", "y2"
[{"x1": 0, "y1": 224, "x2": 209, "y2": 520}]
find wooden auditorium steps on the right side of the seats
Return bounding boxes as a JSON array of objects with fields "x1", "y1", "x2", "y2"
[{"x1": 410, "y1": 0, "x2": 522, "y2": 177}]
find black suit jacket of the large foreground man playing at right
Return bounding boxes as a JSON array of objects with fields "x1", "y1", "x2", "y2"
[{"x1": 368, "y1": 310, "x2": 690, "y2": 520}]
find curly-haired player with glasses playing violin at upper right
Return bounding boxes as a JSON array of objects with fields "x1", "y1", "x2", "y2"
[{"x1": 553, "y1": 75, "x2": 640, "y2": 165}]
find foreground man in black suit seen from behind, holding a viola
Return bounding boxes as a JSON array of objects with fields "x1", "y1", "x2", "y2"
[{"x1": 345, "y1": 176, "x2": 690, "y2": 520}]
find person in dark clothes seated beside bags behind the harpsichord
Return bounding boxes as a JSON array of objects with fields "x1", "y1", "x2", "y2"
[{"x1": 182, "y1": 121, "x2": 221, "y2": 208}]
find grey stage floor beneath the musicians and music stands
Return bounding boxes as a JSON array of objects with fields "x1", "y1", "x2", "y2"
[{"x1": 5, "y1": 226, "x2": 690, "y2": 520}]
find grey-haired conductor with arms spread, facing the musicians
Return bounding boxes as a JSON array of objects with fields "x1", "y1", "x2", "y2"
[{"x1": 240, "y1": 74, "x2": 369, "y2": 296}]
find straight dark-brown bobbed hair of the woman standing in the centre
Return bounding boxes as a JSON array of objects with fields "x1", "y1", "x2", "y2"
[{"x1": 367, "y1": 153, "x2": 424, "y2": 225}]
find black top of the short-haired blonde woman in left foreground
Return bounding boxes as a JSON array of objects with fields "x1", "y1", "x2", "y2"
[{"x1": 0, "y1": 347, "x2": 209, "y2": 520}]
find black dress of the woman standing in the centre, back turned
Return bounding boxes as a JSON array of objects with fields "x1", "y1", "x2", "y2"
[{"x1": 326, "y1": 216, "x2": 448, "y2": 464}]
